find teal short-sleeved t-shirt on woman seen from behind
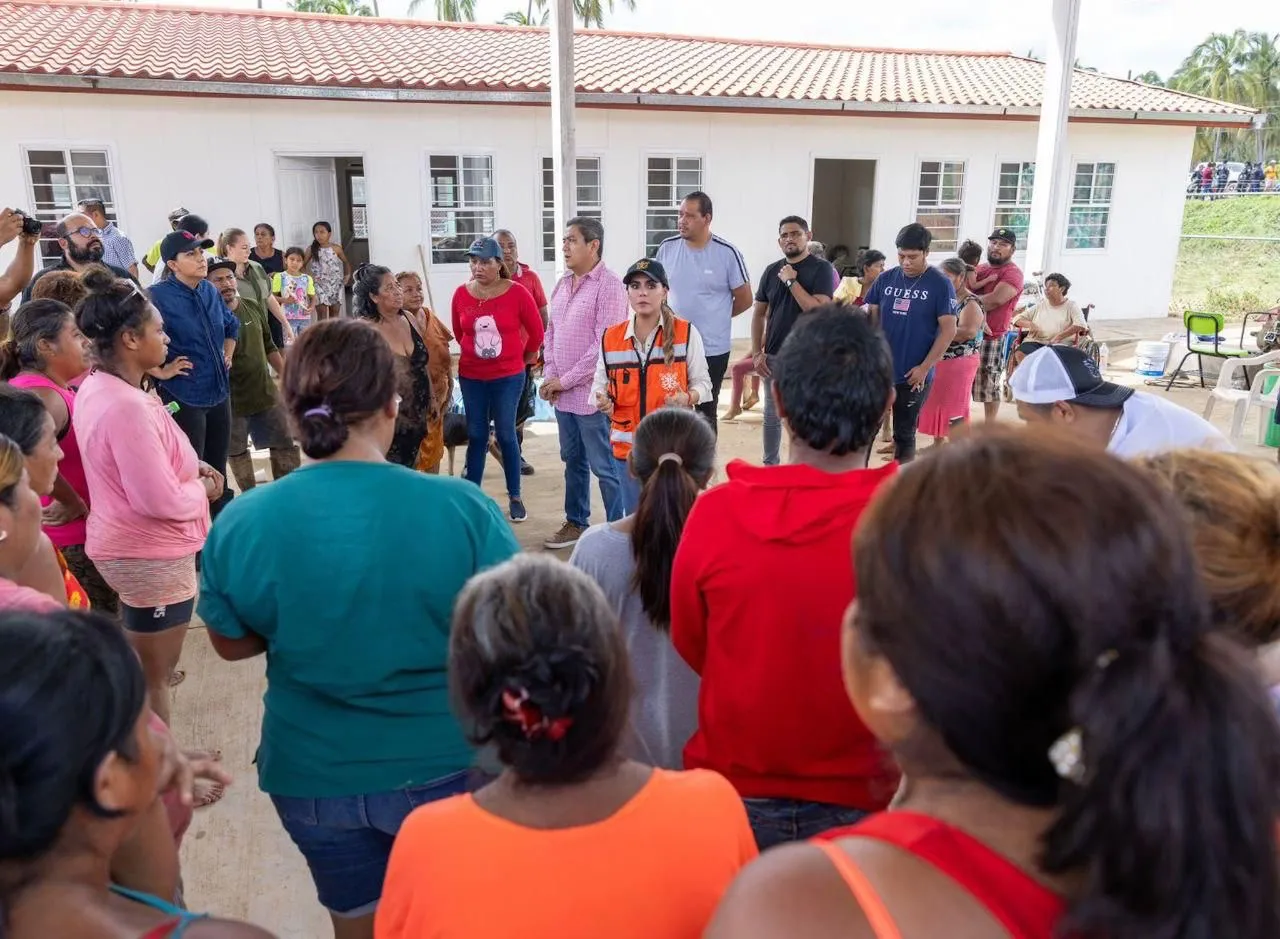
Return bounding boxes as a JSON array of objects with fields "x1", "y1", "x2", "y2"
[{"x1": 198, "y1": 462, "x2": 520, "y2": 798}]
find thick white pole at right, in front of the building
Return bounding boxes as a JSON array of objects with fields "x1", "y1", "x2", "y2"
[{"x1": 1027, "y1": 0, "x2": 1080, "y2": 274}]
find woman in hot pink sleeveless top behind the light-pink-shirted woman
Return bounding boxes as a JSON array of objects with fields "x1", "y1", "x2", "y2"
[{"x1": 0, "y1": 298, "x2": 119, "y2": 615}]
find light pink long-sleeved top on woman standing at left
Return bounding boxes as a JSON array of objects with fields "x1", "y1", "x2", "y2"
[{"x1": 72, "y1": 370, "x2": 209, "y2": 560}]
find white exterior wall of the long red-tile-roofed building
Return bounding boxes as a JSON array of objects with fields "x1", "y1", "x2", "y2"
[{"x1": 0, "y1": 92, "x2": 1193, "y2": 324}]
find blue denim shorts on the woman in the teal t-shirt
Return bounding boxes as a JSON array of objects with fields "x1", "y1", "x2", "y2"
[{"x1": 271, "y1": 770, "x2": 472, "y2": 919}]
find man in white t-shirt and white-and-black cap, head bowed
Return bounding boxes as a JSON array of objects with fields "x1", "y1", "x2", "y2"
[{"x1": 1009, "y1": 345, "x2": 1235, "y2": 459}]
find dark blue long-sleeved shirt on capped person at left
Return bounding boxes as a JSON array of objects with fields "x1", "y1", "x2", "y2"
[{"x1": 151, "y1": 276, "x2": 239, "y2": 408}]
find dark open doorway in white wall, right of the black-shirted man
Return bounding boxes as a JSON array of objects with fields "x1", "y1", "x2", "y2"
[{"x1": 810, "y1": 159, "x2": 876, "y2": 276}]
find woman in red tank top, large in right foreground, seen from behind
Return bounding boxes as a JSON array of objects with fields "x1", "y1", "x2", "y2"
[{"x1": 707, "y1": 431, "x2": 1280, "y2": 939}]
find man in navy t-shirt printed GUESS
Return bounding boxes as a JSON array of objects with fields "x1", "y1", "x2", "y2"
[{"x1": 867, "y1": 223, "x2": 956, "y2": 463}]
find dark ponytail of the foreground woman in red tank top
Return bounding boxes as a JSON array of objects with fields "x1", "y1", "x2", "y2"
[{"x1": 1043, "y1": 633, "x2": 1280, "y2": 939}]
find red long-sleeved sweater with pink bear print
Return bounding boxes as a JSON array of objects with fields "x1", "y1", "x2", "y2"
[{"x1": 453, "y1": 281, "x2": 543, "y2": 381}]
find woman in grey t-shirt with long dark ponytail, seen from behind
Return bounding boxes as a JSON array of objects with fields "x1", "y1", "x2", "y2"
[{"x1": 570, "y1": 408, "x2": 716, "y2": 769}]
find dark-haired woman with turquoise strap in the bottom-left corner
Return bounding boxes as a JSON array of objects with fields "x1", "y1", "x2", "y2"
[{"x1": 0, "y1": 611, "x2": 271, "y2": 939}]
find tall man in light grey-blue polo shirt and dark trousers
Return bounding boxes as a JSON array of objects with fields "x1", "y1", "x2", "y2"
[{"x1": 655, "y1": 192, "x2": 751, "y2": 430}]
